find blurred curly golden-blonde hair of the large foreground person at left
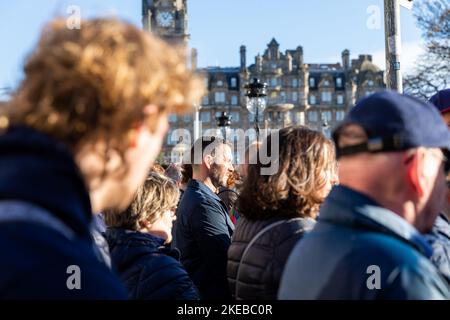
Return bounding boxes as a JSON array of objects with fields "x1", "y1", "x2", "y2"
[{"x1": 8, "y1": 18, "x2": 203, "y2": 156}]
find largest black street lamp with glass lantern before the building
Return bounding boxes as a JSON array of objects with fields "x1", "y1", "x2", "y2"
[{"x1": 245, "y1": 78, "x2": 267, "y2": 142}]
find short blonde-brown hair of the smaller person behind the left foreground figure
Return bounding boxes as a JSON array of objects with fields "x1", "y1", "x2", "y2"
[{"x1": 105, "y1": 172, "x2": 180, "y2": 231}]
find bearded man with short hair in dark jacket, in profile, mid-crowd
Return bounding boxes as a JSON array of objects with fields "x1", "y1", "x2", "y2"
[{"x1": 173, "y1": 137, "x2": 234, "y2": 300}]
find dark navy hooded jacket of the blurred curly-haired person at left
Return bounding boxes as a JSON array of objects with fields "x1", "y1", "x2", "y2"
[{"x1": 0, "y1": 127, "x2": 126, "y2": 299}]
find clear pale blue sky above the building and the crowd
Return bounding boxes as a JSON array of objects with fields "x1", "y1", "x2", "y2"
[{"x1": 0, "y1": 0, "x2": 421, "y2": 88}]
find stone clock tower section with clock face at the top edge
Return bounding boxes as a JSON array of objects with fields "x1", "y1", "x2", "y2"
[{"x1": 142, "y1": 0, "x2": 189, "y2": 46}]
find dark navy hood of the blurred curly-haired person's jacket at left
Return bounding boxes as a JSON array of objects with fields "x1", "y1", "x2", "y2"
[{"x1": 0, "y1": 126, "x2": 92, "y2": 237}]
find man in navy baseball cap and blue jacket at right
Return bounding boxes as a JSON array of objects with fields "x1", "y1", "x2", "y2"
[{"x1": 279, "y1": 91, "x2": 450, "y2": 300}]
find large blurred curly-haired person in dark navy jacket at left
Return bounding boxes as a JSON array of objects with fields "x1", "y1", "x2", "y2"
[{"x1": 0, "y1": 19, "x2": 202, "y2": 299}]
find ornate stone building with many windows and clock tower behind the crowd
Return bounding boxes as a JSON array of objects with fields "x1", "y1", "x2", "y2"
[{"x1": 143, "y1": 0, "x2": 385, "y2": 161}]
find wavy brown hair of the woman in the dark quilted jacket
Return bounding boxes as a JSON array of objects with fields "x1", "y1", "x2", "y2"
[{"x1": 237, "y1": 126, "x2": 336, "y2": 220}]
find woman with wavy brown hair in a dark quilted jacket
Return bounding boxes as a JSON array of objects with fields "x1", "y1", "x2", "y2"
[{"x1": 227, "y1": 127, "x2": 337, "y2": 300}]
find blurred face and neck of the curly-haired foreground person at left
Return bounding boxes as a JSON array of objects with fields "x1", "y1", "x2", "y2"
[{"x1": 76, "y1": 107, "x2": 168, "y2": 212}]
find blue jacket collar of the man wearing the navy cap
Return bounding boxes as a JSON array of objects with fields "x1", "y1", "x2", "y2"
[{"x1": 318, "y1": 185, "x2": 432, "y2": 258}]
